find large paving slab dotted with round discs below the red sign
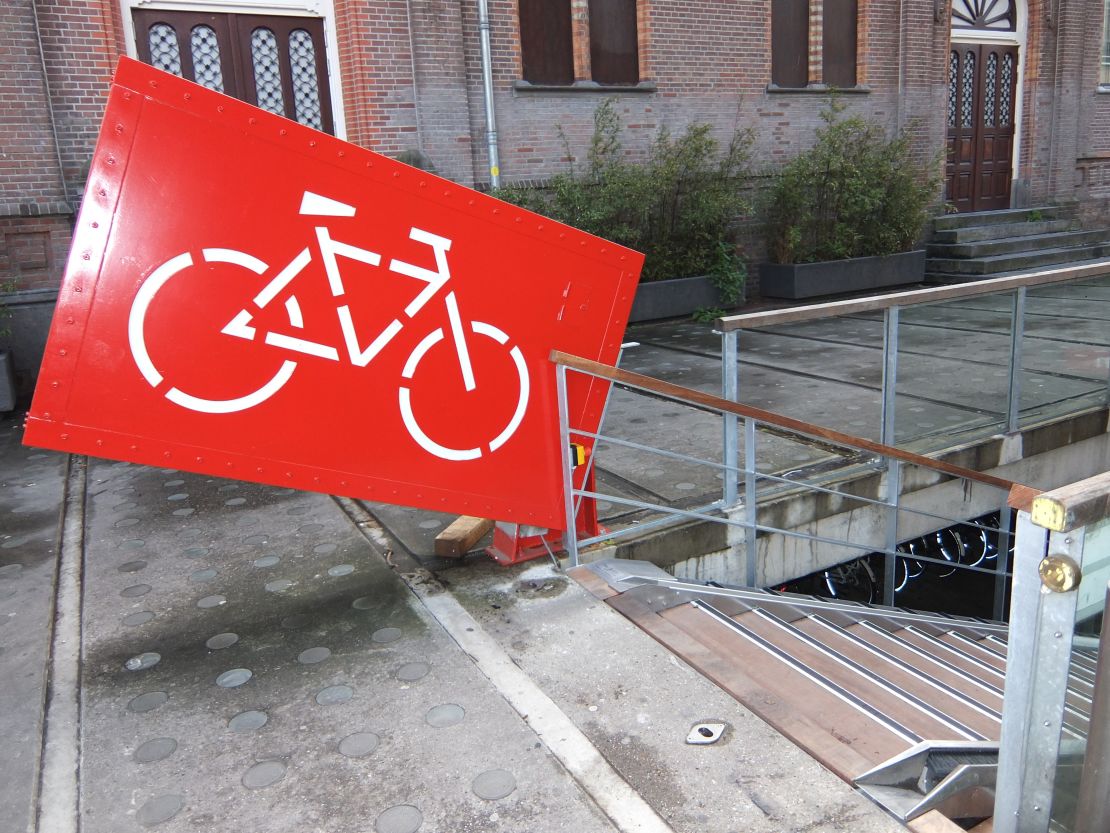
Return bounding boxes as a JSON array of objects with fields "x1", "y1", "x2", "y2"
[{"x1": 81, "y1": 461, "x2": 612, "y2": 833}]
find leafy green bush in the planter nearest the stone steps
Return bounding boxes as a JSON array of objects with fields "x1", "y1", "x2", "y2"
[{"x1": 763, "y1": 99, "x2": 940, "y2": 263}]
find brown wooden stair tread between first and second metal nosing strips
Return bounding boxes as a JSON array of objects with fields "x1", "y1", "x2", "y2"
[{"x1": 739, "y1": 613, "x2": 970, "y2": 741}]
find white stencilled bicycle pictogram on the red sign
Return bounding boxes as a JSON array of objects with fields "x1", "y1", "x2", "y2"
[{"x1": 128, "y1": 191, "x2": 529, "y2": 461}]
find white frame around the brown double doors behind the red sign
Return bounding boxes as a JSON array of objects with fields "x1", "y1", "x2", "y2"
[{"x1": 120, "y1": 0, "x2": 346, "y2": 140}]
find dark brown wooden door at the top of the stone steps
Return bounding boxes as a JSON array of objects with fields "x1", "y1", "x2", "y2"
[{"x1": 945, "y1": 43, "x2": 1018, "y2": 211}]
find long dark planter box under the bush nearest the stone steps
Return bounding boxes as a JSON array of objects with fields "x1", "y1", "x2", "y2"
[{"x1": 759, "y1": 249, "x2": 925, "y2": 299}]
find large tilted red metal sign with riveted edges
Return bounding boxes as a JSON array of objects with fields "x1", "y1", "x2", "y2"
[{"x1": 26, "y1": 59, "x2": 643, "y2": 529}]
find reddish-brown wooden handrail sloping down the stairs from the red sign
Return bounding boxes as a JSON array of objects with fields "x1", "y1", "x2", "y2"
[{"x1": 551, "y1": 350, "x2": 1027, "y2": 492}]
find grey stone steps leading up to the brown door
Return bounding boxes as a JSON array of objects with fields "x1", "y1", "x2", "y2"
[{"x1": 925, "y1": 205, "x2": 1110, "y2": 283}]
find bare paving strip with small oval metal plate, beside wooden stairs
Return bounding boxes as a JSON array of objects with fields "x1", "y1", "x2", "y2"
[{"x1": 444, "y1": 562, "x2": 904, "y2": 833}]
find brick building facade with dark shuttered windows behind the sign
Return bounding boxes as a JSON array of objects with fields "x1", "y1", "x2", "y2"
[{"x1": 0, "y1": 0, "x2": 1110, "y2": 395}]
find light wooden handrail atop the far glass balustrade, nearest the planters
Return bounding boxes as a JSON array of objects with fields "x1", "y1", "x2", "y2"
[{"x1": 716, "y1": 260, "x2": 1110, "y2": 332}]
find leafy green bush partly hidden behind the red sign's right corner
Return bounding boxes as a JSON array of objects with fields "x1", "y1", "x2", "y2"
[{"x1": 495, "y1": 99, "x2": 751, "y2": 284}]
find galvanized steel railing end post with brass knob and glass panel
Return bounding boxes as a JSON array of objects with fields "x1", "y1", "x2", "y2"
[{"x1": 995, "y1": 473, "x2": 1110, "y2": 833}]
